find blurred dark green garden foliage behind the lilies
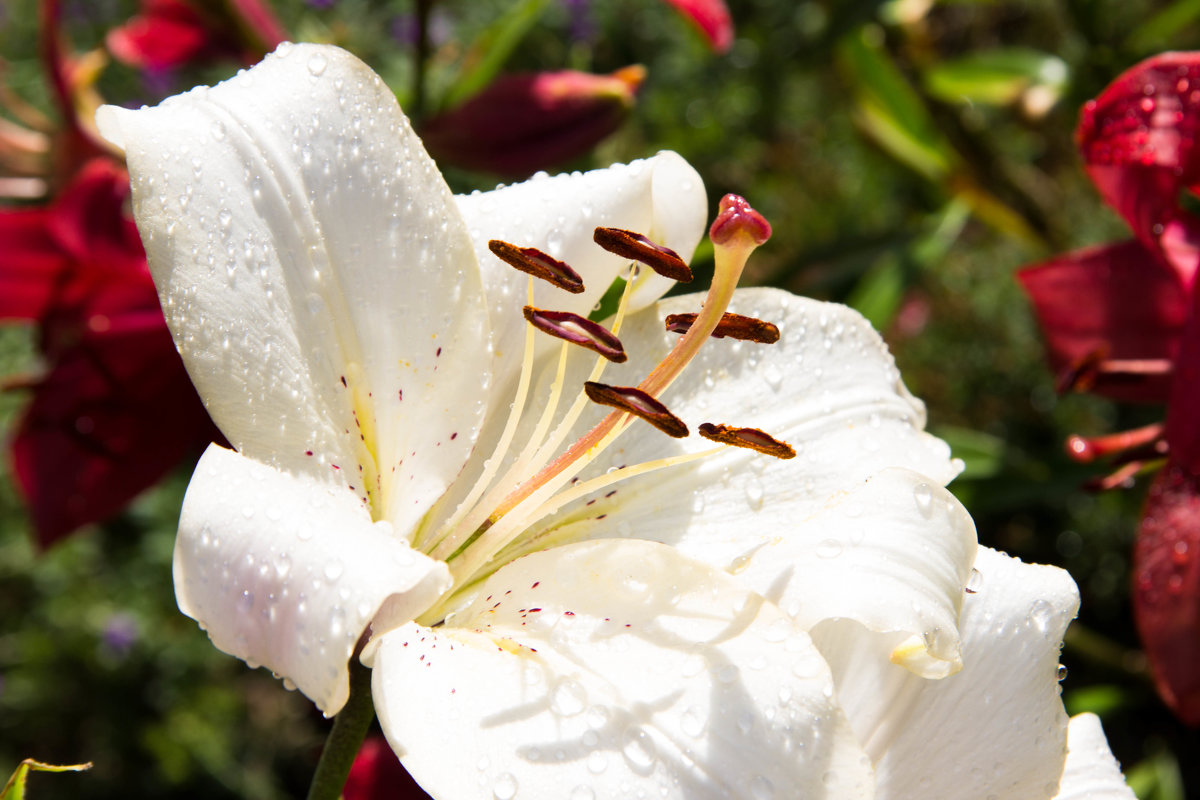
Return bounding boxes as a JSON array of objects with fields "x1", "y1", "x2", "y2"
[{"x1": 0, "y1": 0, "x2": 1200, "y2": 800}]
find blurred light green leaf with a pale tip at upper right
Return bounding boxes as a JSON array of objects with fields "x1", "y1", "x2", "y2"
[{"x1": 924, "y1": 47, "x2": 1068, "y2": 106}]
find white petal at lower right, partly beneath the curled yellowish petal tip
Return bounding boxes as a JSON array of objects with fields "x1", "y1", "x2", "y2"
[{"x1": 812, "y1": 548, "x2": 1079, "y2": 800}]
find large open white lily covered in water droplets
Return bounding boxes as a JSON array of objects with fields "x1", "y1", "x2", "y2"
[{"x1": 97, "y1": 46, "x2": 1123, "y2": 800}]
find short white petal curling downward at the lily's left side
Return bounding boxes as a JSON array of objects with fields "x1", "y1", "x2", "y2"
[{"x1": 174, "y1": 445, "x2": 450, "y2": 715}]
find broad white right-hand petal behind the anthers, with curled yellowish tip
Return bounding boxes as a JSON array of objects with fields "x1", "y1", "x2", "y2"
[{"x1": 540, "y1": 289, "x2": 976, "y2": 676}]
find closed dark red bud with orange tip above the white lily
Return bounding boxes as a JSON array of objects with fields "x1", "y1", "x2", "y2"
[{"x1": 421, "y1": 66, "x2": 646, "y2": 178}]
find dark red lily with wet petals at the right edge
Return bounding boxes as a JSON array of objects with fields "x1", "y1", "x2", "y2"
[{"x1": 1019, "y1": 53, "x2": 1200, "y2": 726}]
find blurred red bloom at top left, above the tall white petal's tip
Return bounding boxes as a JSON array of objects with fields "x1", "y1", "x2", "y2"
[{"x1": 106, "y1": 0, "x2": 287, "y2": 70}]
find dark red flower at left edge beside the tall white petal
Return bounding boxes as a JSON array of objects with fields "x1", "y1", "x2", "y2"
[{"x1": 0, "y1": 158, "x2": 218, "y2": 545}]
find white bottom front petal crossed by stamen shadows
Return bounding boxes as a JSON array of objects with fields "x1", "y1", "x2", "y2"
[{"x1": 373, "y1": 540, "x2": 871, "y2": 800}]
